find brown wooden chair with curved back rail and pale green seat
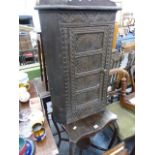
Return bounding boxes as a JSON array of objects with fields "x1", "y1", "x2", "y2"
[{"x1": 107, "y1": 68, "x2": 135, "y2": 154}]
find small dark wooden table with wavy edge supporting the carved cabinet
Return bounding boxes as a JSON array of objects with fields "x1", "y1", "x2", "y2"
[{"x1": 63, "y1": 111, "x2": 117, "y2": 155}]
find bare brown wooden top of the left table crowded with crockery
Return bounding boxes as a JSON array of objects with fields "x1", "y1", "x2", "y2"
[{"x1": 20, "y1": 81, "x2": 59, "y2": 155}]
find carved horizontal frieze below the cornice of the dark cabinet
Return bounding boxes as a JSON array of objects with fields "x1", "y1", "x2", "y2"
[{"x1": 58, "y1": 11, "x2": 115, "y2": 26}]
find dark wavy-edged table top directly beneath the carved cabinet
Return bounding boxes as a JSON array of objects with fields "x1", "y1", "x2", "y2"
[{"x1": 63, "y1": 110, "x2": 117, "y2": 143}]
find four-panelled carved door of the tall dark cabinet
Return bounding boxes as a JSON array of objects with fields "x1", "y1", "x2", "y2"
[{"x1": 69, "y1": 26, "x2": 108, "y2": 118}]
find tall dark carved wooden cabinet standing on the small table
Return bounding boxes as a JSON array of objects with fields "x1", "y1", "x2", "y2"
[{"x1": 36, "y1": 0, "x2": 120, "y2": 124}]
